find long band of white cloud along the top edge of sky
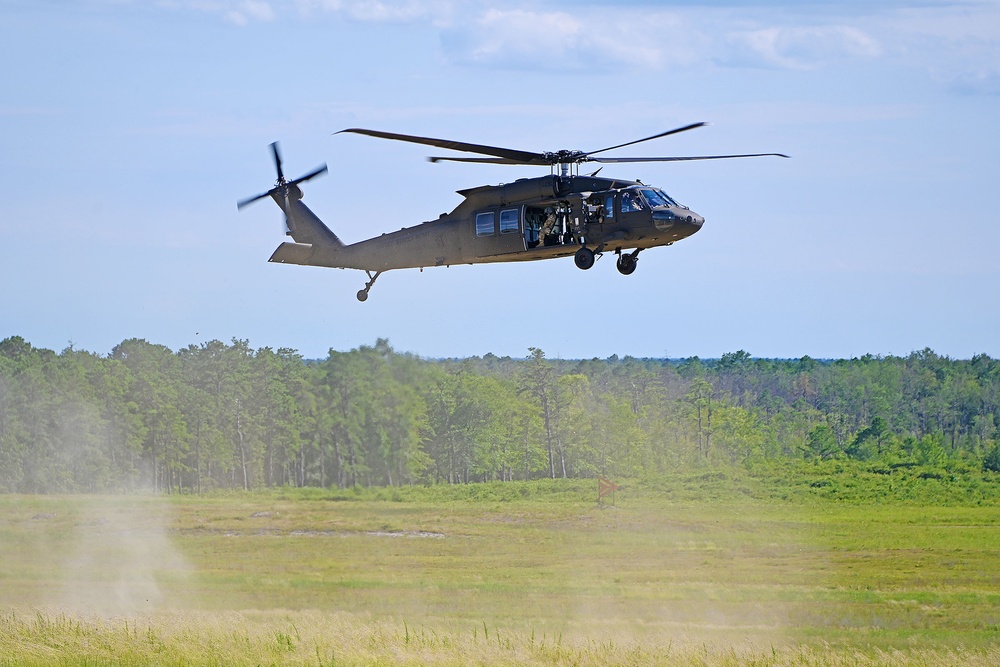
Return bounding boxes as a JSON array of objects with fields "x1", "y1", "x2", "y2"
[{"x1": 141, "y1": 0, "x2": 1000, "y2": 94}]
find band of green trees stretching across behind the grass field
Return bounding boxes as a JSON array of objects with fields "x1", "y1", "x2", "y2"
[{"x1": 0, "y1": 336, "x2": 1000, "y2": 493}]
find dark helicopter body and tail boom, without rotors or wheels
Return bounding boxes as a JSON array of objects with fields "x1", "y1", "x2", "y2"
[{"x1": 270, "y1": 175, "x2": 704, "y2": 274}]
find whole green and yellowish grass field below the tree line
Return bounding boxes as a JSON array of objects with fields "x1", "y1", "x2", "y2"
[{"x1": 0, "y1": 478, "x2": 1000, "y2": 665}]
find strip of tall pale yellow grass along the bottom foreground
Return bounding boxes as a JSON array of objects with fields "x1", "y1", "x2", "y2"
[{"x1": 0, "y1": 611, "x2": 1000, "y2": 667}]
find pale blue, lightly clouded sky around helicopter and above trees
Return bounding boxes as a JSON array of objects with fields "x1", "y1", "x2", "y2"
[{"x1": 0, "y1": 0, "x2": 1000, "y2": 359}]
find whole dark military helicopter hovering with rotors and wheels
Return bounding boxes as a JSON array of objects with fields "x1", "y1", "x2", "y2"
[{"x1": 237, "y1": 123, "x2": 788, "y2": 301}]
